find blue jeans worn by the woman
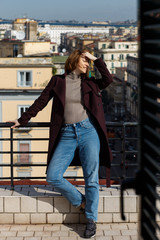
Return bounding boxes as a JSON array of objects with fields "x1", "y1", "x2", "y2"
[{"x1": 47, "y1": 118, "x2": 100, "y2": 221}]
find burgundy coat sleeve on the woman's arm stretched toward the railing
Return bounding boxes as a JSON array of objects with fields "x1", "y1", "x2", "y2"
[{"x1": 18, "y1": 77, "x2": 56, "y2": 125}]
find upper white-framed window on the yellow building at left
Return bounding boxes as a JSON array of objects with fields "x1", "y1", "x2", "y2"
[{"x1": 18, "y1": 71, "x2": 32, "y2": 87}]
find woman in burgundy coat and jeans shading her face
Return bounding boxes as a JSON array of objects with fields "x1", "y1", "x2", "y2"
[{"x1": 9, "y1": 50, "x2": 113, "y2": 238}]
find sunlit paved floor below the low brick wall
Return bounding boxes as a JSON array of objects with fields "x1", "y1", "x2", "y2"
[{"x1": 0, "y1": 223, "x2": 139, "y2": 240}]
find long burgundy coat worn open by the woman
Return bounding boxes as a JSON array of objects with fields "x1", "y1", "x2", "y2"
[{"x1": 18, "y1": 58, "x2": 113, "y2": 186}]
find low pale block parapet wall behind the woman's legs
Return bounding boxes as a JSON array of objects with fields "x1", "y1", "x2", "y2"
[{"x1": 0, "y1": 185, "x2": 142, "y2": 224}]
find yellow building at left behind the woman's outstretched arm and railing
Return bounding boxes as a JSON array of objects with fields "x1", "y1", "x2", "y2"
[{"x1": 0, "y1": 57, "x2": 52, "y2": 177}]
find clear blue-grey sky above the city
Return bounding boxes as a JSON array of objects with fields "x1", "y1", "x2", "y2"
[{"x1": 0, "y1": 0, "x2": 138, "y2": 22}]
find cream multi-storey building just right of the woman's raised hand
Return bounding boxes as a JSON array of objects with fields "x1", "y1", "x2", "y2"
[{"x1": 95, "y1": 40, "x2": 138, "y2": 74}]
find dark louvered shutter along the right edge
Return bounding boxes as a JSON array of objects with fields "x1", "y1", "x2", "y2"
[{"x1": 139, "y1": 0, "x2": 160, "y2": 240}]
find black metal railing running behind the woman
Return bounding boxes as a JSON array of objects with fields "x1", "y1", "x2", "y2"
[{"x1": 0, "y1": 122, "x2": 138, "y2": 189}]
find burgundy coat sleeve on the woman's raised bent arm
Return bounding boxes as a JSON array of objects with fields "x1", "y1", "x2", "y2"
[{"x1": 94, "y1": 58, "x2": 113, "y2": 89}]
